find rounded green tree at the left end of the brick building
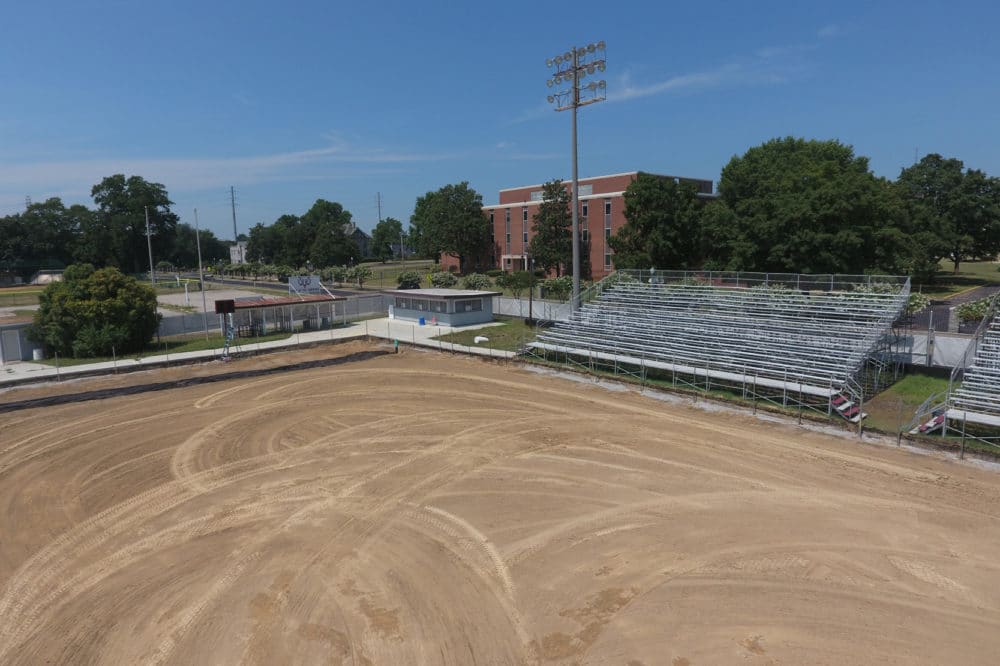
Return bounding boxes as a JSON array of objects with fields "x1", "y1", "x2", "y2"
[{"x1": 410, "y1": 182, "x2": 490, "y2": 273}]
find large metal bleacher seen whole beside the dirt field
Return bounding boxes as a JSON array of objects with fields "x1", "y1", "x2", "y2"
[{"x1": 531, "y1": 271, "x2": 910, "y2": 412}]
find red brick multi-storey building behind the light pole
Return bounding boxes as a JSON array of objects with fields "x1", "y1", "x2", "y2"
[{"x1": 441, "y1": 171, "x2": 715, "y2": 279}]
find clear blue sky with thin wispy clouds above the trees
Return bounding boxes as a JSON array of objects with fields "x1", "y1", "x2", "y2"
[{"x1": 0, "y1": 0, "x2": 1000, "y2": 238}]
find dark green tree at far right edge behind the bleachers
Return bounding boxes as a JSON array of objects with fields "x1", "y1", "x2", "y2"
[{"x1": 896, "y1": 153, "x2": 1000, "y2": 277}]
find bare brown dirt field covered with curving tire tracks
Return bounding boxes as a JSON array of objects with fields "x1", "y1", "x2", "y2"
[{"x1": 0, "y1": 343, "x2": 1000, "y2": 666}]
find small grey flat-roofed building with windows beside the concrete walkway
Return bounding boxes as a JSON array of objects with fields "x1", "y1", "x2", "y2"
[{"x1": 383, "y1": 289, "x2": 500, "y2": 326}]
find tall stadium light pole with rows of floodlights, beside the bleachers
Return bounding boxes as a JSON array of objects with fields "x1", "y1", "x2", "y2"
[{"x1": 545, "y1": 40, "x2": 607, "y2": 312}]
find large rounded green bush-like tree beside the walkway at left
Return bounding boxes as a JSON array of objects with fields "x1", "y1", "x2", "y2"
[{"x1": 31, "y1": 264, "x2": 160, "y2": 357}]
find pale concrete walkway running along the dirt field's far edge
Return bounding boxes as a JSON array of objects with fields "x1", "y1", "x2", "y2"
[{"x1": 0, "y1": 317, "x2": 514, "y2": 390}]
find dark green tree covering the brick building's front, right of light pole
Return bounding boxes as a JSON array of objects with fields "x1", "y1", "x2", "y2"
[{"x1": 608, "y1": 173, "x2": 704, "y2": 268}]
